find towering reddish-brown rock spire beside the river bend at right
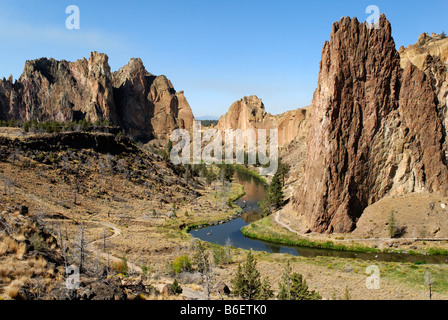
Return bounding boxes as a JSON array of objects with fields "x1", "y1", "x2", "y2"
[{"x1": 293, "y1": 16, "x2": 448, "y2": 232}]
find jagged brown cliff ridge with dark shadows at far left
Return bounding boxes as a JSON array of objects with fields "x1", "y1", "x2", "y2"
[{"x1": 0, "y1": 52, "x2": 193, "y2": 140}]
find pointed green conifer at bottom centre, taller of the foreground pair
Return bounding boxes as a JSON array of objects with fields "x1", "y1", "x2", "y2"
[{"x1": 232, "y1": 251, "x2": 270, "y2": 300}]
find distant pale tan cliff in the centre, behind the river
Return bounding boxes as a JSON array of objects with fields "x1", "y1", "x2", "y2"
[{"x1": 216, "y1": 96, "x2": 309, "y2": 147}]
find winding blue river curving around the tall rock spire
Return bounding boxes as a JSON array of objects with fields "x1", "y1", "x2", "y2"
[{"x1": 190, "y1": 172, "x2": 448, "y2": 264}]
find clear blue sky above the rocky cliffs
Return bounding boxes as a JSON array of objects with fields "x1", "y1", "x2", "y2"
[{"x1": 0, "y1": 0, "x2": 448, "y2": 117}]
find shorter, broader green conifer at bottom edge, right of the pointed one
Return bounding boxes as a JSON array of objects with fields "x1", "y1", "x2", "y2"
[{"x1": 277, "y1": 261, "x2": 322, "y2": 300}]
